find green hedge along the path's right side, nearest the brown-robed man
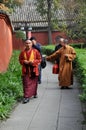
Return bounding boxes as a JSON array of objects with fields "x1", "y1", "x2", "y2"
[{"x1": 74, "y1": 49, "x2": 86, "y2": 101}]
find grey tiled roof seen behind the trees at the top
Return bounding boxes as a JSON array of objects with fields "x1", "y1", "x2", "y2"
[{"x1": 10, "y1": 0, "x2": 77, "y2": 27}]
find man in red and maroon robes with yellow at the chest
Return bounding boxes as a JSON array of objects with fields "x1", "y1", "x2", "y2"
[{"x1": 19, "y1": 40, "x2": 41, "y2": 103}]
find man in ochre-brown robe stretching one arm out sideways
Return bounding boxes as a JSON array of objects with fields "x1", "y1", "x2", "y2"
[{"x1": 46, "y1": 38, "x2": 76, "y2": 88}]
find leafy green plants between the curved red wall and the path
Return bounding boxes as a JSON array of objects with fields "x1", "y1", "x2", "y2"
[{"x1": 0, "y1": 51, "x2": 22, "y2": 119}]
